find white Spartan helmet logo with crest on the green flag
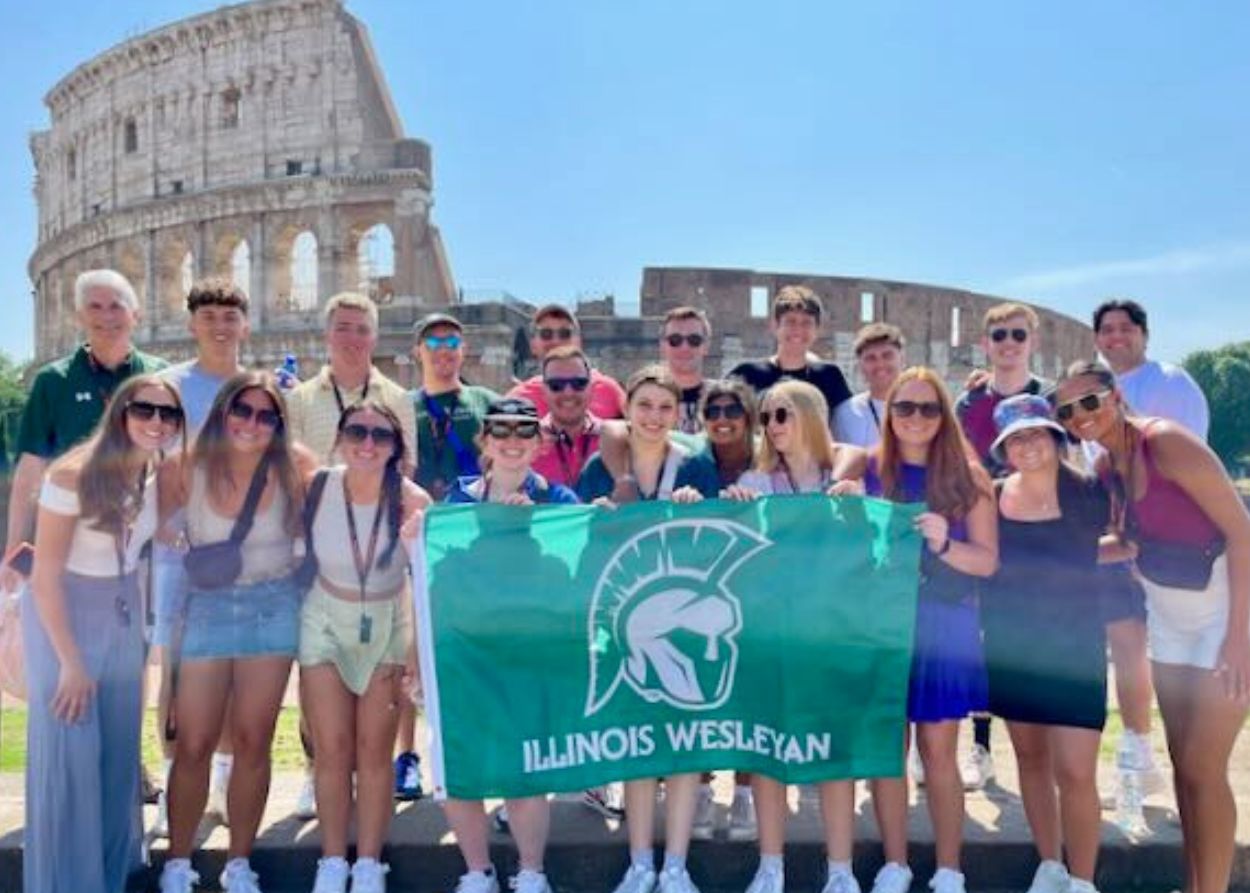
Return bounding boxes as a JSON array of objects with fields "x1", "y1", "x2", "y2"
[{"x1": 585, "y1": 519, "x2": 771, "y2": 717}]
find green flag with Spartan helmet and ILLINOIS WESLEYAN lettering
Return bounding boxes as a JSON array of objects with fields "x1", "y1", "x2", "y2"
[{"x1": 414, "y1": 495, "x2": 923, "y2": 799}]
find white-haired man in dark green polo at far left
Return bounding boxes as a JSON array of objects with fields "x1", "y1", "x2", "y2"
[{"x1": 0, "y1": 270, "x2": 166, "y2": 589}]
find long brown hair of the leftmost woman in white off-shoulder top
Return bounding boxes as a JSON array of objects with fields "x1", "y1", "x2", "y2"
[{"x1": 75, "y1": 375, "x2": 185, "y2": 537}]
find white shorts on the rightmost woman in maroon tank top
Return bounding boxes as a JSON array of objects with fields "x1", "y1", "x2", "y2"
[{"x1": 1139, "y1": 555, "x2": 1231, "y2": 669}]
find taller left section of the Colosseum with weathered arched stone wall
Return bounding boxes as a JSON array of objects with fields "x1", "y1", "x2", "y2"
[{"x1": 30, "y1": 0, "x2": 455, "y2": 364}]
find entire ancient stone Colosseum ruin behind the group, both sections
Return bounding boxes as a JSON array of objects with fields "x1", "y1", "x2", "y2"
[{"x1": 29, "y1": 0, "x2": 1093, "y2": 388}]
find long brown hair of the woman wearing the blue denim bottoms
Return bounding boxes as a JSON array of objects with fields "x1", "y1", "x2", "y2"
[{"x1": 191, "y1": 370, "x2": 304, "y2": 534}]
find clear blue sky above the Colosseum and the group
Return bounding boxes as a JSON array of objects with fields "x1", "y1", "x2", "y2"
[{"x1": 0, "y1": 0, "x2": 1250, "y2": 360}]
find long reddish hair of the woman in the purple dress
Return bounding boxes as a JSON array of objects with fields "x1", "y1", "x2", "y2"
[{"x1": 875, "y1": 366, "x2": 990, "y2": 518}]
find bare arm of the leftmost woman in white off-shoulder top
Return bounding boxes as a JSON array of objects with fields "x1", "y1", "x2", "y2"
[{"x1": 30, "y1": 468, "x2": 95, "y2": 723}]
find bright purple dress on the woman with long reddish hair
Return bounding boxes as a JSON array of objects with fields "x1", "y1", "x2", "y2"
[{"x1": 864, "y1": 459, "x2": 989, "y2": 723}]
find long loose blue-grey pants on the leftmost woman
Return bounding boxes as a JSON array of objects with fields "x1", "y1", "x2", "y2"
[{"x1": 21, "y1": 573, "x2": 144, "y2": 893}]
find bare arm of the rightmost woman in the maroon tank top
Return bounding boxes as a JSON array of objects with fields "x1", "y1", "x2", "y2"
[{"x1": 1149, "y1": 423, "x2": 1250, "y2": 702}]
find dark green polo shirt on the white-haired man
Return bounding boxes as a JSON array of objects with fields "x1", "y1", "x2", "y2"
[{"x1": 18, "y1": 344, "x2": 169, "y2": 459}]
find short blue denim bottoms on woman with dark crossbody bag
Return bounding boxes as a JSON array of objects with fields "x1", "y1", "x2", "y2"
[{"x1": 180, "y1": 577, "x2": 300, "y2": 660}]
